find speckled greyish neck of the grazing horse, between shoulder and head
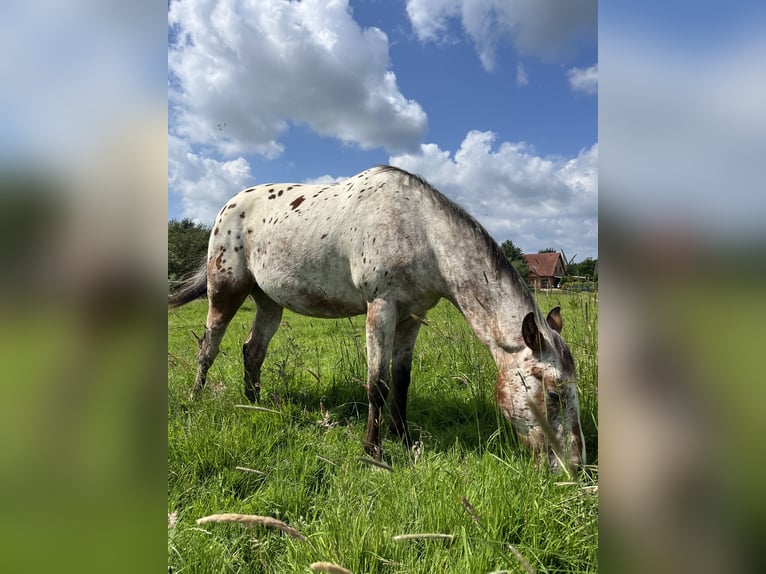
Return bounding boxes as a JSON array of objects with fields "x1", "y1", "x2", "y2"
[{"x1": 441, "y1": 228, "x2": 535, "y2": 360}]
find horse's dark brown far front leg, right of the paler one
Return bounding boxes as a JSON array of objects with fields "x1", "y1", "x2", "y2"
[{"x1": 389, "y1": 317, "x2": 421, "y2": 447}]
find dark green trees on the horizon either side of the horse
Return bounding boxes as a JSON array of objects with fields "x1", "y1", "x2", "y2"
[{"x1": 168, "y1": 223, "x2": 598, "y2": 288}]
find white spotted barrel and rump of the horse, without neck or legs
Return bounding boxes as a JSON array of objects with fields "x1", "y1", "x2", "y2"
[{"x1": 208, "y1": 170, "x2": 448, "y2": 317}]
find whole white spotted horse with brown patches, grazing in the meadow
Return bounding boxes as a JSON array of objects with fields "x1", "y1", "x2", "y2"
[{"x1": 169, "y1": 166, "x2": 585, "y2": 469}]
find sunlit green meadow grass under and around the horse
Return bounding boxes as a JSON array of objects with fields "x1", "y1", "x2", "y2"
[{"x1": 168, "y1": 293, "x2": 598, "y2": 573}]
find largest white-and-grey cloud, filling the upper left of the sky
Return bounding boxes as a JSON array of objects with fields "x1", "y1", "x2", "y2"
[{"x1": 168, "y1": 0, "x2": 427, "y2": 157}]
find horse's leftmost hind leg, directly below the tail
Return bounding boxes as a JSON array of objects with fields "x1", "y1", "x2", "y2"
[{"x1": 192, "y1": 282, "x2": 252, "y2": 399}]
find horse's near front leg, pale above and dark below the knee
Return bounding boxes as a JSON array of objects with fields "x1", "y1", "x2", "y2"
[{"x1": 364, "y1": 299, "x2": 397, "y2": 459}]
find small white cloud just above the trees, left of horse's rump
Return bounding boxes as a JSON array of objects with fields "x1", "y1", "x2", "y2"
[{"x1": 168, "y1": 135, "x2": 254, "y2": 224}]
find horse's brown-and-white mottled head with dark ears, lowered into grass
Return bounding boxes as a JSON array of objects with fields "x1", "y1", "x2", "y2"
[{"x1": 495, "y1": 307, "x2": 585, "y2": 470}]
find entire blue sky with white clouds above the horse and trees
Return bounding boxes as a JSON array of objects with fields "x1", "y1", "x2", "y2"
[{"x1": 168, "y1": 0, "x2": 598, "y2": 260}]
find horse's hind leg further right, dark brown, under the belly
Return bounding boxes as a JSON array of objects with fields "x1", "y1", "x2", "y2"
[{"x1": 242, "y1": 289, "x2": 282, "y2": 403}]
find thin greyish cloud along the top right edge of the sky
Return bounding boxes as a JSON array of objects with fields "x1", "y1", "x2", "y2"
[{"x1": 407, "y1": 0, "x2": 598, "y2": 70}]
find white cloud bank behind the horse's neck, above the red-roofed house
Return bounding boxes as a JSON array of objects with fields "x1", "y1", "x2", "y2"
[{"x1": 389, "y1": 131, "x2": 598, "y2": 258}]
